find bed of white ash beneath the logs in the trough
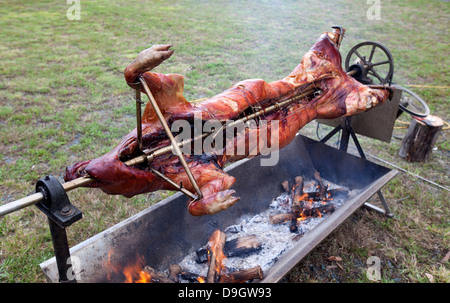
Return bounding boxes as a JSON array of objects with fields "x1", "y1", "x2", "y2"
[{"x1": 179, "y1": 180, "x2": 358, "y2": 282}]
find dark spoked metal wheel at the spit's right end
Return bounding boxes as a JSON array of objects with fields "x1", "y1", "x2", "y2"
[{"x1": 345, "y1": 41, "x2": 394, "y2": 85}]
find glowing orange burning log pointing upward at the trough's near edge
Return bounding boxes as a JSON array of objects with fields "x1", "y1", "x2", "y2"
[{"x1": 206, "y1": 229, "x2": 227, "y2": 283}]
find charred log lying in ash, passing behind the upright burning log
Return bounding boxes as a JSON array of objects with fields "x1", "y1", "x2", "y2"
[{"x1": 195, "y1": 235, "x2": 261, "y2": 263}]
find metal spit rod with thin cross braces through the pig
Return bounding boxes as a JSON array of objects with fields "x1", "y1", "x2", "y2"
[{"x1": 0, "y1": 71, "x2": 370, "y2": 217}]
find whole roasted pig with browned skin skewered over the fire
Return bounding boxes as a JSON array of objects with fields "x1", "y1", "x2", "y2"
[{"x1": 64, "y1": 29, "x2": 389, "y2": 216}]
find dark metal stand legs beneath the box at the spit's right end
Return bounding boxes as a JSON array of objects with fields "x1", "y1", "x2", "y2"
[{"x1": 320, "y1": 117, "x2": 394, "y2": 218}]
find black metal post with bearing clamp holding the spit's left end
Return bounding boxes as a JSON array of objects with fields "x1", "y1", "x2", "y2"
[{"x1": 36, "y1": 175, "x2": 83, "y2": 283}]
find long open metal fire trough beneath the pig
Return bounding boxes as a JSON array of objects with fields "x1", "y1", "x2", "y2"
[{"x1": 40, "y1": 135, "x2": 397, "y2": 283}]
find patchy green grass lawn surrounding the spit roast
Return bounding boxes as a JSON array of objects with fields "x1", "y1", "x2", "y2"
[{"x1": 0, "y1": 0, "x2": 450, "y2": 282}]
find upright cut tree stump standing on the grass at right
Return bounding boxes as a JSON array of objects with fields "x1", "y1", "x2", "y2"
[{"x1": 399, "y1": 115, "x2": 444, "y2": 162}]
